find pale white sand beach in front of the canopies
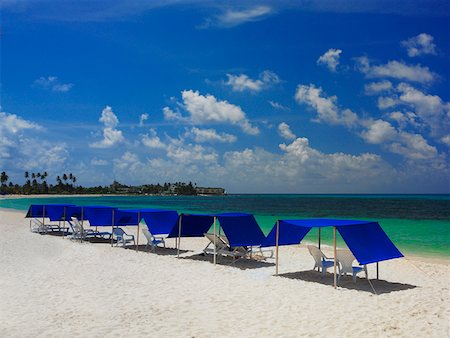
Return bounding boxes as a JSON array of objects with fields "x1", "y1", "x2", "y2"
[{"x1": 0, "y1": 210, "x2": 450, "y2": 337}]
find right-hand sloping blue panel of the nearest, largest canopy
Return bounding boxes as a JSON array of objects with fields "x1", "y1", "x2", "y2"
[{"x1": 337, "y1": 222, "x2": 403, "y2": 264}]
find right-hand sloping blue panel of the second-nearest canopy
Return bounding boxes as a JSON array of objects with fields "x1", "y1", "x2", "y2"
[{"x1": 217, "y1": 213, "x2": 266, "y2": 247}]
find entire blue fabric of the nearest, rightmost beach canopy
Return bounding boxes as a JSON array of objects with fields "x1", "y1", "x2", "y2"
[{"x1": 264, "y1": 218, "x2": 403, "y2": 264}]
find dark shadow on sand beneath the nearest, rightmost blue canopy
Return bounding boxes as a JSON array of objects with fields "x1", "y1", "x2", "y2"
[{"x1": 278, "y1": 270, "x2": 417, "y2": 295}]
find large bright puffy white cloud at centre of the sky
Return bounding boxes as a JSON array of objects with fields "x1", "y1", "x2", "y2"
[{"x1": 163, "y1": 90, "x2": 259, "y2": 135}]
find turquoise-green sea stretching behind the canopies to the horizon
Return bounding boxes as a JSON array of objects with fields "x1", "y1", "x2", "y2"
[{"x1": 0, "y1": 195, "x2": 450, "y2": 259}]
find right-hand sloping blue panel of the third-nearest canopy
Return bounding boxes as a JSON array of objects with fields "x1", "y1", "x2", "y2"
[{"x1": 140, "y1": 209, "x2": 178, "y2": 235}]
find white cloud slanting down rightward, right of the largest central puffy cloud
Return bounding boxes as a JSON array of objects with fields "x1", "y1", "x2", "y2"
[{"x1": 295, "y1": 84, "x2": 358, "y2": 127}]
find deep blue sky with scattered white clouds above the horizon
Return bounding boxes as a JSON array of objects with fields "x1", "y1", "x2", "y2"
[{"x1": 0, "y1": 0, "x2": 450, "y2": 193}]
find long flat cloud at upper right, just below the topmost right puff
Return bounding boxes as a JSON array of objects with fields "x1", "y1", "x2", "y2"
[{"x1": 356, "y1": 56, "x2": 438, "y2": 83}]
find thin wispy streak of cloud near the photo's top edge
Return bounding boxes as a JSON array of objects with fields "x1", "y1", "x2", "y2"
[{"x1": 199, "y1": 6, "x2": 273, "y2": 28}]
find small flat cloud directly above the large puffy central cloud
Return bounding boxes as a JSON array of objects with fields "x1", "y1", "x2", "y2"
[{"x1": 225, "y1": 70, "x2": 281, "y2": 92}]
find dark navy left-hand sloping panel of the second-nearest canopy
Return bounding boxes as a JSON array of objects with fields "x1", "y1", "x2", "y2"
[{"x1": 167, "y1": 214, "x2": 214, "y2": 238}]
